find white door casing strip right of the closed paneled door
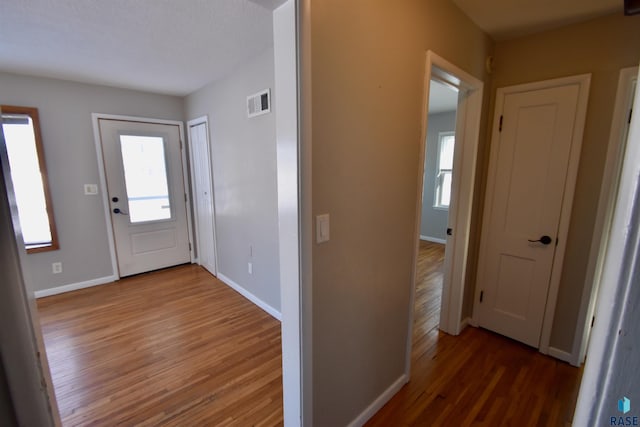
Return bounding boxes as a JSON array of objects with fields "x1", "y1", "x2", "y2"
[{"x1": 570, "y1": 66, "x2": 638, "y2": 366}]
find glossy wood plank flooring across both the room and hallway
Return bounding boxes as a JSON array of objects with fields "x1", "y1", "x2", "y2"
[{"x1": 38, "y1": 242, "x2": 581, "y2": 427}]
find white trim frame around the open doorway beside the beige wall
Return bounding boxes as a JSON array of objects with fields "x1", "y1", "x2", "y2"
[{"x1": 405, "y1": 50, "x2": 484, "y2": 377}]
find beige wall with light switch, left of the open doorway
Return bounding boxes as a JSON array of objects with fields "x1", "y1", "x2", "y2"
[{"x1": 311, "y1": 0, "x2": 492, "y2": 426}]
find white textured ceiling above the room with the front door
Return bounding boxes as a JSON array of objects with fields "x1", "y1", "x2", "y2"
[{"x1": 0, "y1": 0, "x2": 275, "y2": 95}]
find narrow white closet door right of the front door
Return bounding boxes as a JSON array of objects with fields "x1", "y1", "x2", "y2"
[{"x1": 189, "y1": 121, "x2": 217, "y2": 276}]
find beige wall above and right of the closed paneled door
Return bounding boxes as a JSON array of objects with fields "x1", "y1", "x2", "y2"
[{"x1": 491, "y1": 14, "x2": 640, "y2": 352}]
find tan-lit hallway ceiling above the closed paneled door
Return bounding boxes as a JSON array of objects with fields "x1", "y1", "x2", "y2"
[{"x1": 453, "y1": 0, "x2": 623, "y2": 40}]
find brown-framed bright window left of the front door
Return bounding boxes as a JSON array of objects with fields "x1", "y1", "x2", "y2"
[{"x1": 0, "y1": 105, "x2": 59, "y2": 253}]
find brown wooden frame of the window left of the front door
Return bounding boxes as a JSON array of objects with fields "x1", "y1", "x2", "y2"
[{"x1": 0, "y1": 105, "x2": 60, "y2": 254}]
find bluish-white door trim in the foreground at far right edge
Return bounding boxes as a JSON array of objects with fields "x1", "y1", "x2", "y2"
[{"x1": 573, "y1": 63, "x2": 640, "y2": 425}]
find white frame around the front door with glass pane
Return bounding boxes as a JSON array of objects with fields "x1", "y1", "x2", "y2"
[{"x1": 91, "y1": 113, "x2": 195, "y2": 280}]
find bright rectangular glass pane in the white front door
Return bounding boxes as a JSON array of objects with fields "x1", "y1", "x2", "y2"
[{"x1": 120, "y1": 135, "x2": 171, "y2": 223}]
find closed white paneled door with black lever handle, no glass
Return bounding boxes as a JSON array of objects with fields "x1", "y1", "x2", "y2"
[{"x1": 475, "y1": 79, "x2": 580, "y2": 347}]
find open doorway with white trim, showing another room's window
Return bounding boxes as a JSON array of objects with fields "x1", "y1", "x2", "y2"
[{"x1": 406, "y1": 51, "x2": 483, "y2": 377}]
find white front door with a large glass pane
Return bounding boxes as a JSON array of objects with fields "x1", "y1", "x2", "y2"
[{"x1": 98, "y1": 118, "x2": 191, "y2": 276}]
